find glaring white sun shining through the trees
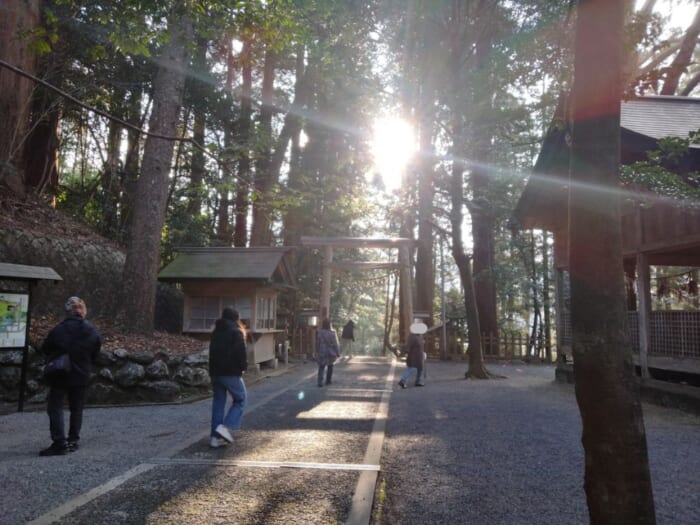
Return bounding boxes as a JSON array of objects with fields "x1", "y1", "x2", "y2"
[{"x1": 372, "y1": 117, "x2": 417, "y2": 191}]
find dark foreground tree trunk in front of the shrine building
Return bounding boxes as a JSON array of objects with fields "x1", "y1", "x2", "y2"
[{"x1": 569, "y1": 0, "x2": 656, "y2": 524}]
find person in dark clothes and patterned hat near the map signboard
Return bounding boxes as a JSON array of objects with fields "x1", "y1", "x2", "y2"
[{"x1": 39, "y1": 297, "x2": 102, "y2": 456}]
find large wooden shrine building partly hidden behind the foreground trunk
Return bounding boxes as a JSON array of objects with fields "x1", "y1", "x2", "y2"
[{"x1": 515, "y1": 96, "x2": 700, "y2": 377}]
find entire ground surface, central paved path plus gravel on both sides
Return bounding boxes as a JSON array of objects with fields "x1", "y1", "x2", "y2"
[{"x1": 0, "y1": 357, "x2": 700, "y2": 525}]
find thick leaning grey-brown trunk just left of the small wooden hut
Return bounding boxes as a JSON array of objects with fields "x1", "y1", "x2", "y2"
[{"x1": 119, "y1": 10, "x2": 192, "y2": 332}]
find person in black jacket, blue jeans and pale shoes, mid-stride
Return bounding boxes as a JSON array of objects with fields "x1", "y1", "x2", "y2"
[{"x1": 209, "y1": 308, "x2": 248, "y2": 448}]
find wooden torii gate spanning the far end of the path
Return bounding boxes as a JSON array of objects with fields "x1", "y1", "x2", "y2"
[{"x1": 301, "y1": 237, "x2": 414, "y2": 340}]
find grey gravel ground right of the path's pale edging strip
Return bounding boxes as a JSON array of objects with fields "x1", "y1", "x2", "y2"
[{"x1": 375, "y1": 362, "x2": 700, "y2": 525}]
